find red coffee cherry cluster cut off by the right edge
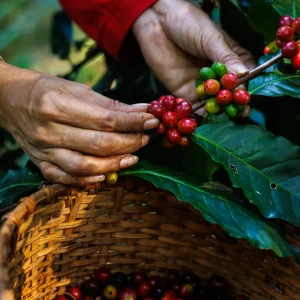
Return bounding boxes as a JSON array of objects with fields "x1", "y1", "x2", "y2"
[{"x1": 276, "y1": 16, "x2": 300, "y2": 70}]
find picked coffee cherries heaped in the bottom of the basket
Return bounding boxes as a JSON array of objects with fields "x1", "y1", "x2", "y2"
[{"x1": 56, "y1": 268, "x2": 250, "y2": 300}]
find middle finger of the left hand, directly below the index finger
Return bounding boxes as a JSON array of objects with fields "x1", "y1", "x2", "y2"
[{"x1": 30, "y1": 124, "x2": 149, "y2": 157}]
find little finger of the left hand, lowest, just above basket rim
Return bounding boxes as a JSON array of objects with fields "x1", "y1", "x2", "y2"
[{"x1": 38, "y1": 161, "x2": 105, "y2": 186}]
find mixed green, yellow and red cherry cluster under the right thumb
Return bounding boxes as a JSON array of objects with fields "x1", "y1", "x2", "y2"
[{"x1": 196, "y1": 62, "x2": 250, "y2": 118}]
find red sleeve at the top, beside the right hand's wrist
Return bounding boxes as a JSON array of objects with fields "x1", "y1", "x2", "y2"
[{"x1": 59, "y1": 0, "x2": 157, "y2": 60}]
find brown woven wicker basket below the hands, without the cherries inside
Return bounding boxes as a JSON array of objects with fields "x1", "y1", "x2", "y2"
[{"x1": 0, "y1": 179, "x2": 300, "y2": 300}]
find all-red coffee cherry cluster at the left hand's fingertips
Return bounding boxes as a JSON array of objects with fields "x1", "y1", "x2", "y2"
[{"x1": 148, "y1": 95, "x2": 197, "y2": 148}]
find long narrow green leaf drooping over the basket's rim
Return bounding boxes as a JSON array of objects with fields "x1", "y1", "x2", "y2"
[{"x1": 120, "y1": 161, "x2": 300, "y2": 260}]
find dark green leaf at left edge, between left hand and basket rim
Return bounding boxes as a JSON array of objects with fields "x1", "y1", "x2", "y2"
[{"x1": 0, "y1": 169, "x2": 42, "y2": 209}]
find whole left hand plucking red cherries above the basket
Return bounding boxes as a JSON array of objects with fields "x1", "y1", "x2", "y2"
[{"x1": 0, "y1": 63, "x2": 158, "y2": 186}]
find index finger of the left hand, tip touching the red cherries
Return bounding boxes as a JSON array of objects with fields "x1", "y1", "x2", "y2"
[{"x1": 42, "y1": 93, "x2": 159, "y2": 132}]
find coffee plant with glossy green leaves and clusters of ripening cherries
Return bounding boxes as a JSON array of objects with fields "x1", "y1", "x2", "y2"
[{"x1": 0, "y1": 0, "x2": 300, "y2": 261}]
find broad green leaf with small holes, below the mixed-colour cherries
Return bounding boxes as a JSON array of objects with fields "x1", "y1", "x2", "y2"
[{"x1": 192, "y1": 122, "x2": 300, "y2": 226}]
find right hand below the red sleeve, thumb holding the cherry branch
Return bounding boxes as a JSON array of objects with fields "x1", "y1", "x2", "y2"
[{"x1": 133, "y1": 0, "x2": 255, "y2": 102}]
